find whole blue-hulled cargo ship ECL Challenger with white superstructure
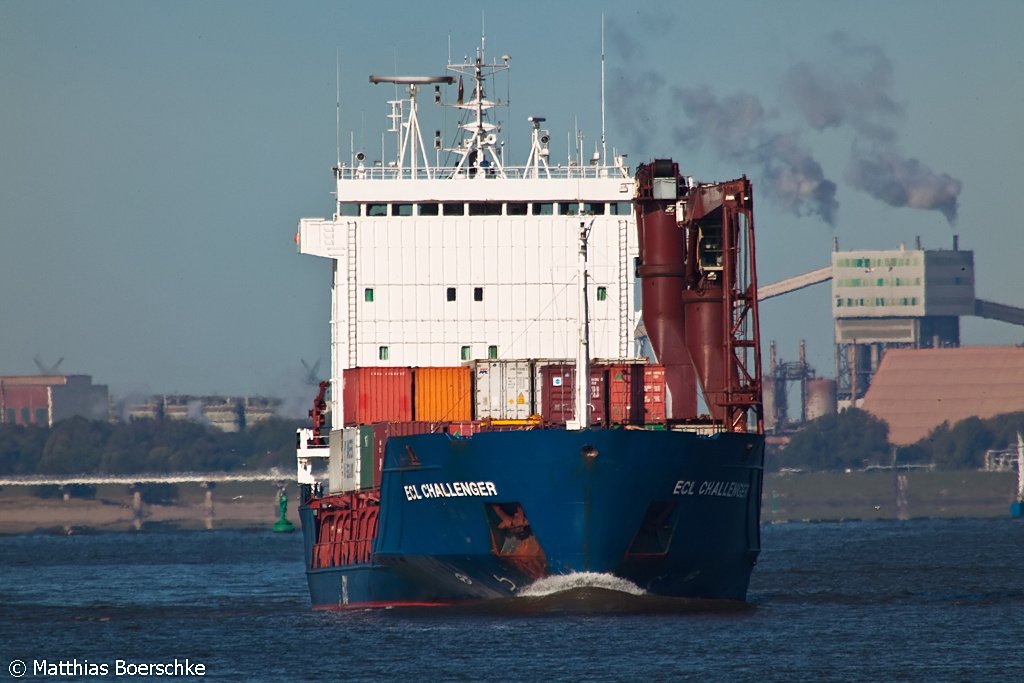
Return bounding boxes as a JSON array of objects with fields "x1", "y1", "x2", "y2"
[{"x1": 296, "y1": 46, "x2": 764, "y2": 609}]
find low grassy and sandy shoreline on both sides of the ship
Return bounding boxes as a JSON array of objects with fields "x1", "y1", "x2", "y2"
[{"x1": 0, "y1": 470, "x2": 1017, "y2": 536}]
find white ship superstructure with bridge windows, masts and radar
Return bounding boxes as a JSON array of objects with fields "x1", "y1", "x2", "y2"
[{"x1": 298, "y1": 49, "x2": 638, "y2": 426}]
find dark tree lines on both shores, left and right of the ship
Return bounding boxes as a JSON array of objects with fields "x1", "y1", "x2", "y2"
[{"x1": 0, "y1": 408, "x2": 1024, "y2": 475}]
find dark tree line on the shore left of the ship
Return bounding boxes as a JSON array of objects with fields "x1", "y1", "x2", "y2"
[{"x1": 0, "y1": 417, "x2": 307, "y2": 475}]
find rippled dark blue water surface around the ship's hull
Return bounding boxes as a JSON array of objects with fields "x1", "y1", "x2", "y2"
[{"x1": 0, "y1": 519, "x2": 1024, "y2": 681}]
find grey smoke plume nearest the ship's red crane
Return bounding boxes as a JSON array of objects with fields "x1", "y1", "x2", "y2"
[{"x1": 673, "y1": 85, "x2": 839, "y2": 224}]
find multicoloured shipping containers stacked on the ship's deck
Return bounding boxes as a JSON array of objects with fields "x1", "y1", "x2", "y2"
[{"x1": 328, "y1": 358, "x2": 666, "y2": 493}]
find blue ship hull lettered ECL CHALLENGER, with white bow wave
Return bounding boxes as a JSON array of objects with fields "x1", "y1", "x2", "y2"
[{"x1": 300, "y1": 429, "x2": 764, "y2": 609}]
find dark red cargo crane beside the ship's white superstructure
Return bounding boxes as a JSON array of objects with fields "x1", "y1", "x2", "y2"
[{"x1": 636, "y1": 159, "x2": 764, "y2": 433}]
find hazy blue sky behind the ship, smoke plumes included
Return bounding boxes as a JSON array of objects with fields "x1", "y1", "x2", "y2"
[{"x1": 0, "y1": 0, "x2": 1024, "y2": 411}]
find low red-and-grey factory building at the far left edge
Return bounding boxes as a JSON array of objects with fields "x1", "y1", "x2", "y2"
[{"x1": 0, "y1": 375, "x2": 110, "y2": 427}]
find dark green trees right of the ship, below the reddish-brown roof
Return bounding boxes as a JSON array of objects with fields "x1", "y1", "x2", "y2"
[{"x1": 767, "y1": 408, "x2": 1024, "y2": 471}]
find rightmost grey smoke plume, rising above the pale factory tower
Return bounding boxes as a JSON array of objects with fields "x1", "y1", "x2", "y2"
[{"x1": 784, "y1": 33, "x2": 961, "y2": 223}]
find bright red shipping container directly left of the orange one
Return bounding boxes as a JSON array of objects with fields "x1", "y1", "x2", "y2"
[{"x1": 342, "y1": 368, "x2": 413, "y2": 427}]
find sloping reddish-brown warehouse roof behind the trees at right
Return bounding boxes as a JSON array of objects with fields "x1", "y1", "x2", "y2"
[{"x1": 862, "y1": 346, "x2": 1024, "y2": 445}]
